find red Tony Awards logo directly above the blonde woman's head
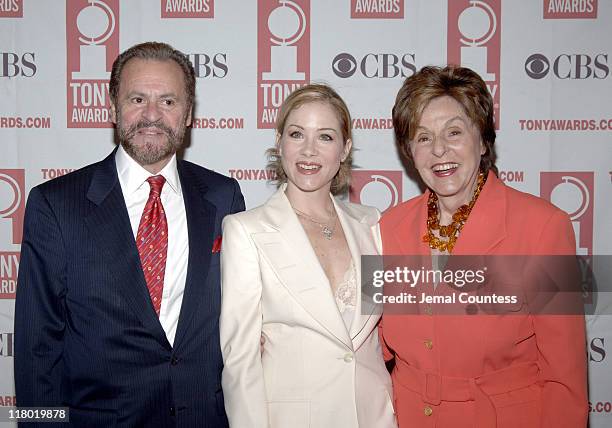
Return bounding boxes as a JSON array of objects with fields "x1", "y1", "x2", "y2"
[{"x1": 257, "y1": 0, "x2": 310, "y2": 129}]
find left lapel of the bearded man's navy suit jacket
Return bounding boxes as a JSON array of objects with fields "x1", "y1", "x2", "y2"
[{"x1": 85, "y1": 151, "x2": 171, "y2": 349}]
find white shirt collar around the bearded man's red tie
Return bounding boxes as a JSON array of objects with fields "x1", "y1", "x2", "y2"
[{"x1": 115, "y1": 145, "x2": 181, "y2": 195}]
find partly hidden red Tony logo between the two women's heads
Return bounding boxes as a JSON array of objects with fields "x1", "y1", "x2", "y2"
[{"x1": 349, "y1": 170, "x2": 402, "y2": 212}]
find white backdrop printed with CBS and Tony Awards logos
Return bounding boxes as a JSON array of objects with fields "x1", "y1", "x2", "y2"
[{"x1": 0, "y1": 0, "x2": 612, "y2": 428}]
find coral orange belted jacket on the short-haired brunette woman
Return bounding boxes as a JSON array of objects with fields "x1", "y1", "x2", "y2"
[{"x1": 380, "y1": 173, "x2": 588, "y2": 428}]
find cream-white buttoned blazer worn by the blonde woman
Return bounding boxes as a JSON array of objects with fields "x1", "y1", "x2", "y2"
[{"x1": 220, "y1": 186, "x2": 396, "y2": 428}]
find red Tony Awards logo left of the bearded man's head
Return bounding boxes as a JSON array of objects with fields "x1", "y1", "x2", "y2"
[{"x1": 66, "y1": 0, "x2": 119, "y2": 128}]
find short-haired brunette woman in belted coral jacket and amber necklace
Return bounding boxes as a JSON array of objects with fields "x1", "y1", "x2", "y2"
[{"x1": 381, "y1": 67, "x2": 587, "y2": 428}]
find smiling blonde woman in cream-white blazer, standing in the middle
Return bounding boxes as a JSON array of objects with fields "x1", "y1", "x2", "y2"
[{"x1": 220, "y1": 85, "x2": 395, "y2": 428}]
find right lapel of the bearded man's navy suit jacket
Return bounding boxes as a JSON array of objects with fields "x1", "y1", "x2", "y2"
[{"x1": 174, "y1": 161, "x2": 220, "y2": 349}]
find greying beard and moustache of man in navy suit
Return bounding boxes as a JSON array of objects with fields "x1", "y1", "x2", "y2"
[{"x1": 117, "y1": 112, "x2": 186, "y2": 165}]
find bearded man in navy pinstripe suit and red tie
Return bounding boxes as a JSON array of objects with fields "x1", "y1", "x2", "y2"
[{"x1": 15, "y1": 43, "x2": 244, "y2": 428}]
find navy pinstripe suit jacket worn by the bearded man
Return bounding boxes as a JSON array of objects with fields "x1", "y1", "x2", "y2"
[{"x1": 15, "y1": 152, "x2": 244, "y2": 428}]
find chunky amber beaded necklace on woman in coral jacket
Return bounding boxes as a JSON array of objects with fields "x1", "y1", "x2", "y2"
[{"x1": 423, "y1": 172, "x2": 487, "y2": 253}]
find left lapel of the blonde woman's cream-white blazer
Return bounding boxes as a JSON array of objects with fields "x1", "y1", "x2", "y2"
[{"x1": 253, "y1": 186, "x2": 352, "y2": 349}]
